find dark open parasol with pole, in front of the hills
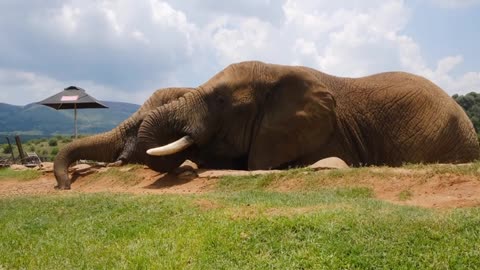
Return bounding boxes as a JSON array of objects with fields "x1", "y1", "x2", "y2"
[{"x1": 38, "y1": 86, "x2": 108, "y2": 138}]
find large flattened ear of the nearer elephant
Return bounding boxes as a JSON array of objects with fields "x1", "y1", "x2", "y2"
[{"x1": 248, "y1": 72, "x2": 336, "y2": 170}]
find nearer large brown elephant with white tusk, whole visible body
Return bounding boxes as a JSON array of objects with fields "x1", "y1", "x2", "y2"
[{"x1": 137, "y1": 61, "x2": 480, "y2": 172}]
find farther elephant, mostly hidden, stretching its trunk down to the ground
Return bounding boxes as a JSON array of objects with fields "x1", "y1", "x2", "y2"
[{"x1": 54, "y1": 88, "x2": 194, "y2": 189}]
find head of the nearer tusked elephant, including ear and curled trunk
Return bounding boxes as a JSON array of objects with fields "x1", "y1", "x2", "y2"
[{"x1": 138, "y1": 62, "x2": 335, "y2": 171}]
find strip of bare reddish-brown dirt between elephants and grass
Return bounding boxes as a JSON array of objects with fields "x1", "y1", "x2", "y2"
[{"x1": 0, "y1": 162, "x2": 480, "y2": 208}]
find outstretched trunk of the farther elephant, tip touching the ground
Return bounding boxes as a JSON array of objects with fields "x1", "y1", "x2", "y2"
[{"x1": 53, "y1": 129, "x2": 122, "y2": 189}]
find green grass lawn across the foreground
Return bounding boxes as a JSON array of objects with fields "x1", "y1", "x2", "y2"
[{"x1": 0, "y1": 169, "x2": 480, "y2": 269}]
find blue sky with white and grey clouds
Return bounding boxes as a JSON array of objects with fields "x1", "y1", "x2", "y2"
[{"x1": 0, "y1": 0, "x2": 480, "y2": 105}]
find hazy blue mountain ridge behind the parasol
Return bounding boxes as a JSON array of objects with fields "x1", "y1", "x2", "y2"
[{"x1": 0, "y1": 101, "x2": 140, "y2": 143}]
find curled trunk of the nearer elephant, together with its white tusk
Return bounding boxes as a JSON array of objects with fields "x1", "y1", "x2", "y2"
[{"x1": 138, "y1": 91, "x2": 207, "y2": 172}]
